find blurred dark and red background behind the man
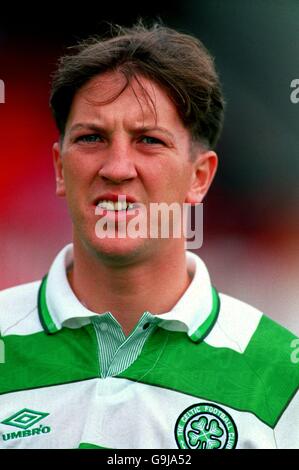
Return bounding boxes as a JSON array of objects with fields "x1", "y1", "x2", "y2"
[{"x1": 0, "y1": 0, "x2": 299, "y2": 334}]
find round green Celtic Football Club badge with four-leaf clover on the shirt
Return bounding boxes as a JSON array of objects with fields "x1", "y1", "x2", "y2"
[{"x1": 175, "y1": 403, "x2": 238, "y2": 449}]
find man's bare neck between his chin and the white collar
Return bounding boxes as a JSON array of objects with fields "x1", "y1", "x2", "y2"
[{"x1": 68, "y1": 242, "x2": 190, "y2": 334}]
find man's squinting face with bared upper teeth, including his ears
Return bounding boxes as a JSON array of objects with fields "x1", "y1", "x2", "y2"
[{"x1": 54, "y1": 72, "x2": 216, "y2": 260}]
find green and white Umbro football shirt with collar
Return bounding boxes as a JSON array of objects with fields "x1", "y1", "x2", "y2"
[{"x1": 0, "y1": 245, "x2": 299, "y2": 449}]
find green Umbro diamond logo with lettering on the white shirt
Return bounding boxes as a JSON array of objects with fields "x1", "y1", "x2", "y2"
[{"x1": 1, "y1": 408, "x2": 51, "y2": 441}]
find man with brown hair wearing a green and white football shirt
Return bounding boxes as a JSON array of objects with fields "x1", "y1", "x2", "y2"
[{"x1": 0, "y1": 24, "x2": 299, "y2": 449}]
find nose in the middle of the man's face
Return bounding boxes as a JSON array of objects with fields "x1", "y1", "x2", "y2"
[{"x1": 98, "y1": 138, "x2": 137, "y2": 183}]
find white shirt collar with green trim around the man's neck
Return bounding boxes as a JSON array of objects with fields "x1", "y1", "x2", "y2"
[{"x1": 38, "y1": 244, "x2": 220, "y2": 342}]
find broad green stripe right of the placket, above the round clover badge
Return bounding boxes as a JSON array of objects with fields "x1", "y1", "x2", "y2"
[{"x1": 118, "y1": 317, "x2": 299, "y2": 427}]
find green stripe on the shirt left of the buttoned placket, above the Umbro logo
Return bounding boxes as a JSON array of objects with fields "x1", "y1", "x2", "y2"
[{"x1": 0, "y1": 325, "x2": 100, "y2": 394}]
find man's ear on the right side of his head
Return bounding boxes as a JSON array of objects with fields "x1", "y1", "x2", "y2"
[{"x1": 185, "y1": 150, "x2": 218, "y2": 204}]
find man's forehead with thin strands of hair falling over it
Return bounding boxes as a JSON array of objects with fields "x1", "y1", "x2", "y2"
[{"x1": 67, "y1": 72, "x2": 187, "y2": 133}]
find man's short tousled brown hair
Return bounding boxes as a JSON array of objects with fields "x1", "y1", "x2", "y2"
[{"x1": 50, "y1": 21, "x2": 224, "y2": 148}]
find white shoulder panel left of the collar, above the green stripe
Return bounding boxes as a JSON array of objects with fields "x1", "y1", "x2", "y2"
[{"x1": 0, "y1": 281, "x2": 40, "y2": 336}]
